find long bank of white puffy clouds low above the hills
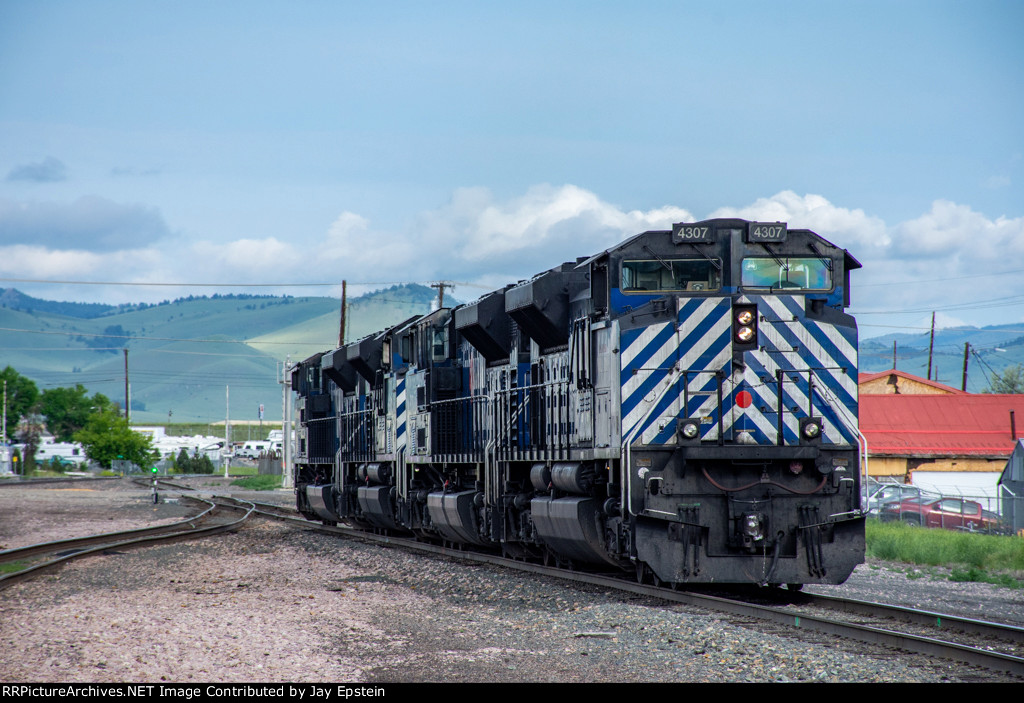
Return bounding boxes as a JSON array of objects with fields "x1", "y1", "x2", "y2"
[{"x1": 0, "y1": 185, "x2": 1024, "y2": 332}]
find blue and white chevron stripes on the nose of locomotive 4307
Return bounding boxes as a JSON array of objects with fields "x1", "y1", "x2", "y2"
[{"x1": 621, "y1": 296, "x2": 857, "y2": 445}]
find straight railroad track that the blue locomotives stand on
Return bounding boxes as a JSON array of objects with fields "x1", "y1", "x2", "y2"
[{"x1": 234, "y1": 502, "x2": 1024, "y2": 677}]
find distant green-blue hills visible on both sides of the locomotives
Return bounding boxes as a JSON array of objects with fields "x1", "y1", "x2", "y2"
[{"x1": 8, "y1": 283, "x2": 1024, "y2": 424}]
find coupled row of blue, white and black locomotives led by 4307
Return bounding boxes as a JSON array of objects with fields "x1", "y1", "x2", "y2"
[{"x1": 292, "y1": 219, "x2": 864, "y2": 586}]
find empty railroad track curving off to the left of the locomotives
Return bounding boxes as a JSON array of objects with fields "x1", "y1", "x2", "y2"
[{"x1": 0, "y1": 495, "x2": 255, "y2": 588}]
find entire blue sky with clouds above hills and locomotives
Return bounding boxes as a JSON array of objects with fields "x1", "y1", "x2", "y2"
[{"x1": 0, "y1": 0, "x2": 1024, "y2": 338}]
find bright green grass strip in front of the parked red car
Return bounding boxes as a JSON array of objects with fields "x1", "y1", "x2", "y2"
[{"x1": 866, "y1": 519, "x2": 1024, "y2": 588}]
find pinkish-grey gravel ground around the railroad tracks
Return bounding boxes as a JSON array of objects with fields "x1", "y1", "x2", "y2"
[{"x1": 0, "y1": 479, "x2": 1024, "y2": 684}]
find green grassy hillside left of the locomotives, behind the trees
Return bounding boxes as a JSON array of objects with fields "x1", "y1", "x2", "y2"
[{"x1": 0, "y1": 284, "x2": 444, "y2": 424}]
